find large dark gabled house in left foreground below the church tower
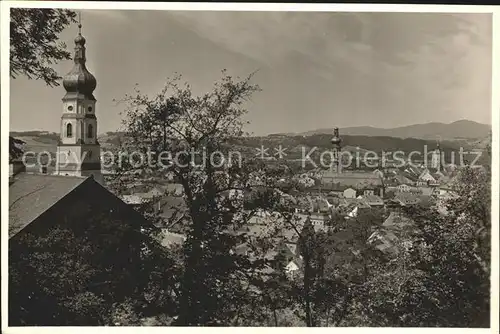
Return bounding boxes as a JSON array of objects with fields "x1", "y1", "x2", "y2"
[{"x1": 6, "y1": 173, "x2": 149, "y2": 326}]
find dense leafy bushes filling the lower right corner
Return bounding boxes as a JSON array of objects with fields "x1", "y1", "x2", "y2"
[{"x1": 280, "y1": 163, "x2": 491, "y2": 327}]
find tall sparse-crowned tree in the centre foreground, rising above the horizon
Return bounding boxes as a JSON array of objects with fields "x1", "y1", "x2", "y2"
[{"x1": 117, "y1": 71, "x2": 290, "y2": 325}]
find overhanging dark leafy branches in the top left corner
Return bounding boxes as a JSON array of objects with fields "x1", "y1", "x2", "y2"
[{"x1": 10, "y1": 8, "x2": 76, "y2": 87}]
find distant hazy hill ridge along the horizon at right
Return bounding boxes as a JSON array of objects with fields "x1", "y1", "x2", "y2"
[{"x1": 301, "y1": 120, "x2": 491, "y2": 140}]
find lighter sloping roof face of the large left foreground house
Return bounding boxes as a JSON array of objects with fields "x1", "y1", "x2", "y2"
[{"x1": 9, "y1": 173, "x2": 87, "y2": 238}]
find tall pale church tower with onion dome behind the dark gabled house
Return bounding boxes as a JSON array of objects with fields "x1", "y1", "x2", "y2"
[{"x1": 56, "y1": 17, "x2": 103, "y2": 183}]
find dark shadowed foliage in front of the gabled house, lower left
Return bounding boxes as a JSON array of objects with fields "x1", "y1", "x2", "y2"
[{"x1": 9, "y1": 205, "x2": 143, "y2": 325}]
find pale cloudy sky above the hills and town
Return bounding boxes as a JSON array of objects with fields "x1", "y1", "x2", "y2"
[{"x1": 10, "y1": 10, "x2": 492, "y2": 135}]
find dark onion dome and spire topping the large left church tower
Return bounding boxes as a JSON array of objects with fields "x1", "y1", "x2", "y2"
[{"x1": 63, "y1": 24, "x2": 97, "y2": 100}]
